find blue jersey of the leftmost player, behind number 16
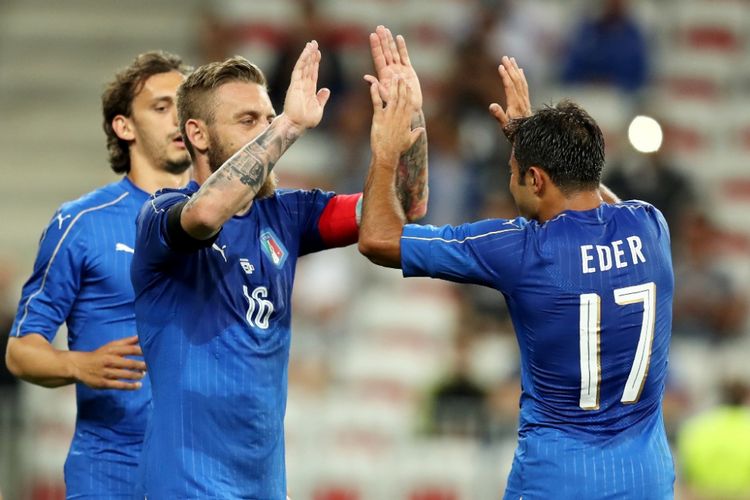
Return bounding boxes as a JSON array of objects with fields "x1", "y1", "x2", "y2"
[{"x1": 10, "y1": 177, "x2": 151, "y2": 499}]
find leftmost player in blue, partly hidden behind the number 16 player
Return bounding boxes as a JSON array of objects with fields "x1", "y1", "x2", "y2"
[{"x1": 6, "y1": 52, "x2": 190, "y2": 499}]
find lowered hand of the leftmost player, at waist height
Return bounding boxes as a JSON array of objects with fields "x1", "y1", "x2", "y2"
[{"x1": 70, "y1": 335, "x2": 146, "y2": 391}]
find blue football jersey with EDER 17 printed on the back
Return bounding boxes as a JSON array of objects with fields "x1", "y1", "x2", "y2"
[{"x1": 401, "y1": 201, "x2": 674, "y2": 499}]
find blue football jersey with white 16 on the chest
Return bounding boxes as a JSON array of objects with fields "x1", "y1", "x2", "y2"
[{"x1": 131, "y1": 183, "x2": 333, "y2": 500}]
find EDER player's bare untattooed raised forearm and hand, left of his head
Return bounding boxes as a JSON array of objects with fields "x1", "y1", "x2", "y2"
[{"x1": 359, "y1": 76, "x2": 424, "y2": 267}]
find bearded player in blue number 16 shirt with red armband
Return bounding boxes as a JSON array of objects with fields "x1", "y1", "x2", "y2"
[{"x1": 131, "y1": 30, "x2": 427, "y2": 500}]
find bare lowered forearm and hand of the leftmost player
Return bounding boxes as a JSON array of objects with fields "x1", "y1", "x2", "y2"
[{"x1": 5, "y1": 333, "x2": 146, "y2": 390}]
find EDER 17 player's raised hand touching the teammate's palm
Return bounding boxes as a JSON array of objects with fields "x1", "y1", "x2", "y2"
[{"x1": 370, "y1": 75, "x2": 424, "y2": 162}]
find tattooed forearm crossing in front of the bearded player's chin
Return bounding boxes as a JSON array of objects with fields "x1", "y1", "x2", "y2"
[{"x1": 185, "y1": 121, "x2": 300, "y2": 209}]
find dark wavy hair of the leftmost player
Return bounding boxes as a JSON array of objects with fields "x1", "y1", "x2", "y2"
[{"x1": 102, "y1": 50, "x2": 191, "y2": 174}]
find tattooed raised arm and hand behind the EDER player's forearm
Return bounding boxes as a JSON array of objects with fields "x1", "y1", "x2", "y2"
[{"x1": 365, "y1": 26, "x2": 428, "y2": 221}]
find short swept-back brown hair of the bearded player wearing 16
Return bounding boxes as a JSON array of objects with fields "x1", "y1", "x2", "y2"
[{"x1": 177, "y1": 56, "x2": 267, "y2": 159}]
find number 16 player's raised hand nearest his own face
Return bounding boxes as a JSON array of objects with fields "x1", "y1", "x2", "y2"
[{"x1": 284, "y1": 40, "x2": 331, "y2": 129}]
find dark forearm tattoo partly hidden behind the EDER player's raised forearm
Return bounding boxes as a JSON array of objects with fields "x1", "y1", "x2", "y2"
[{"x1": 396, "y1": 111, "x2": 427, "y2": 220}]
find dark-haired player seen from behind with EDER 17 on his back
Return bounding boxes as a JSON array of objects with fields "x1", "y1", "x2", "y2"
[{"x1": 359, "y1": 58, "x2": 674, "y2": 500}]
